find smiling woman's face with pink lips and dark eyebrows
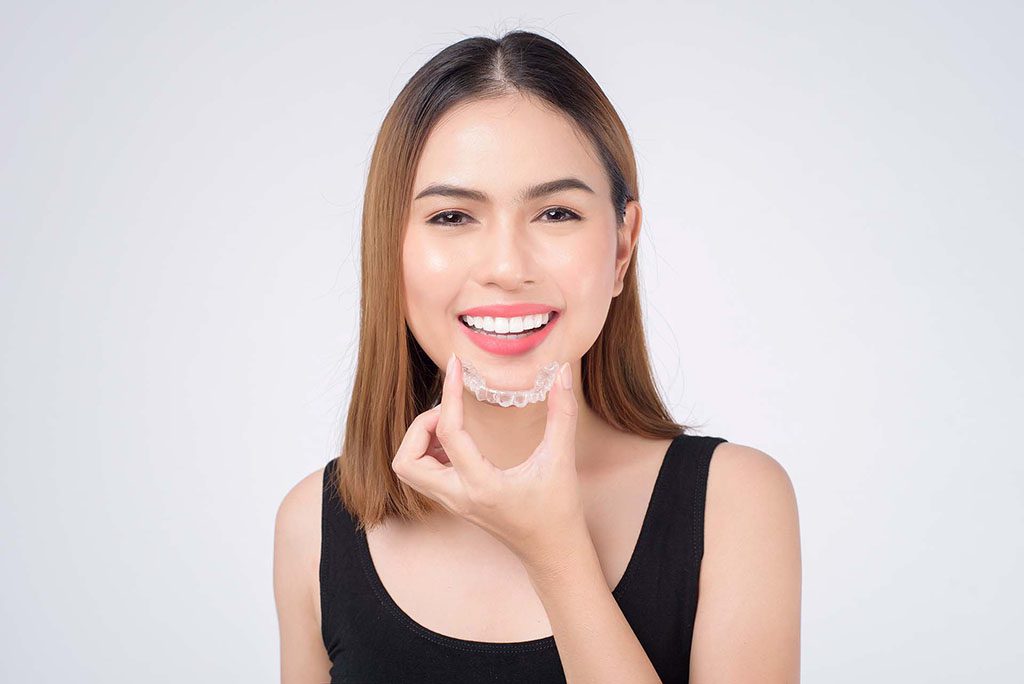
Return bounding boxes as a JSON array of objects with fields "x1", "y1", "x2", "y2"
[{"x1": 402, "y1": 94, "x2": 640, "y2": 389}]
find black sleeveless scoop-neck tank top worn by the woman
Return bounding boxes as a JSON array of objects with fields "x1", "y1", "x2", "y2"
[{"x1": 319, "y1": 434, "x2": 727, "y2": 684}]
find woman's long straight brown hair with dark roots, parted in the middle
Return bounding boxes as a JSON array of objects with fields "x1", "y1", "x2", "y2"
[{"x1": 331, "y1": 31, "x2": 689, "y2": 528}]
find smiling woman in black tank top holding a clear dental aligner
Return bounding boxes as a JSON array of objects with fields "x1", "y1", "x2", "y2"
[{"x1": 274, "y1": 32, "x2": 801, "y2": 683}]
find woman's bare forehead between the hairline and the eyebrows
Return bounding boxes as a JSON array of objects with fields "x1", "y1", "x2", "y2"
[{"x1": 414, "y1": 94, "x2": 607, "y2": 199}]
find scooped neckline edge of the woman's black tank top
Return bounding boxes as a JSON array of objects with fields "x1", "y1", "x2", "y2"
[{"x1": 355, "y1": 434, "x2": 686, "y2": 653}]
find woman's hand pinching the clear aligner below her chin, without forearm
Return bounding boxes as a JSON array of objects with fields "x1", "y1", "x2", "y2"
[{"x1": 391, "y1": 354, "x2": 588, "y2": 566}]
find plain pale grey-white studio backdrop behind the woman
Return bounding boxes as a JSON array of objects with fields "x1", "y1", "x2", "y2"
[{"x1": 0, "y1": 0, "x2": 1024, "y2": 683}]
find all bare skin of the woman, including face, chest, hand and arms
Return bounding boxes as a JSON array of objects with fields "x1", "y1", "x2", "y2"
[{"x1": 274, "y1": 89, "x2": 801, "y2": 684}]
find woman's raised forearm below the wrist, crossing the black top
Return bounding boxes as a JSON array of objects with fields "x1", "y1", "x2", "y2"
[{"x1": 523, "y1": 522, "x2": 662, "y2": 684}]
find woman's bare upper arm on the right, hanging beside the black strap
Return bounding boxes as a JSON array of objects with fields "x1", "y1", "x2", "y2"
[{"x1": 690, "y1": 442, "x2": 801, "y2": 684}]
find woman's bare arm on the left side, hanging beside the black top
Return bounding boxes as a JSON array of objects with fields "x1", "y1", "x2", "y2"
[{"x1": 273, "y1": 470, "x2": 331, "y2": 684}]
